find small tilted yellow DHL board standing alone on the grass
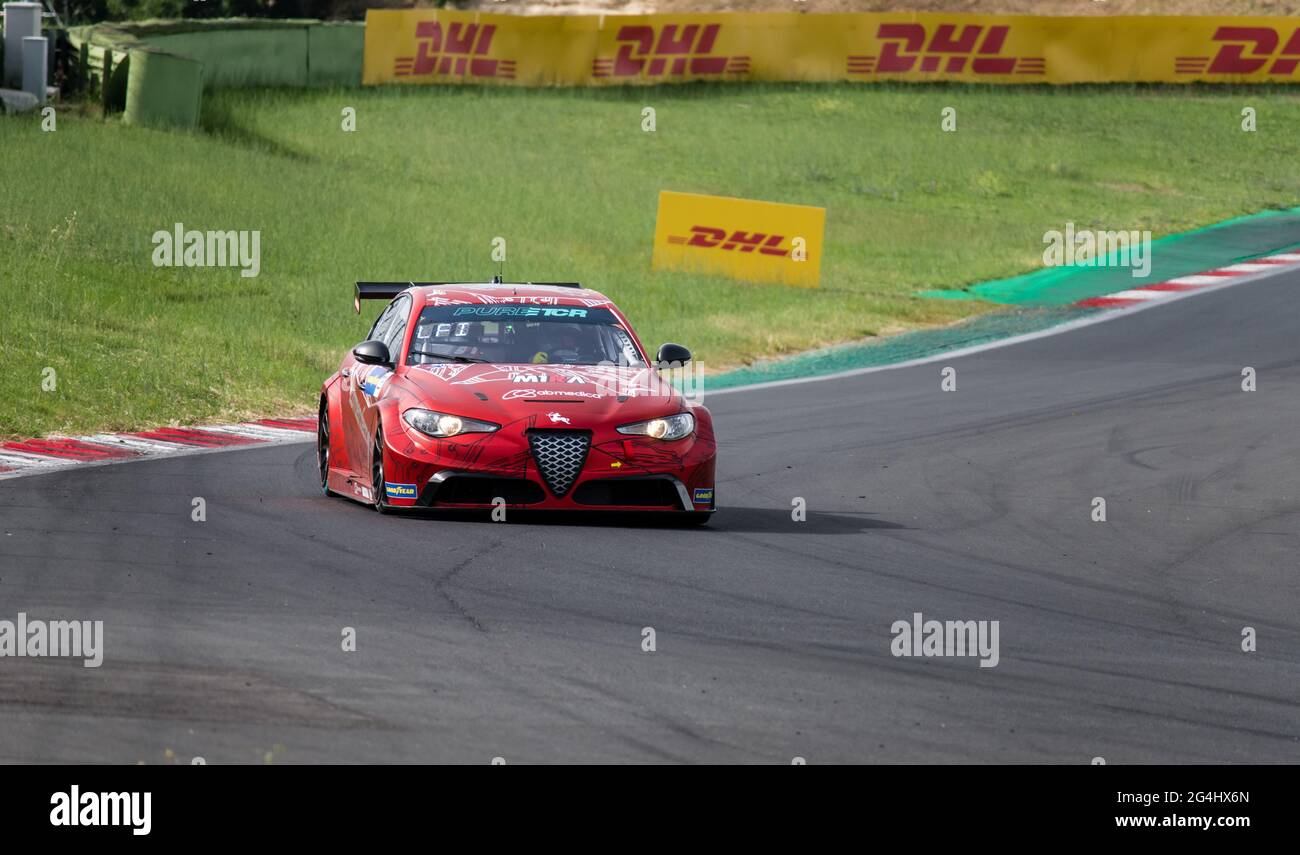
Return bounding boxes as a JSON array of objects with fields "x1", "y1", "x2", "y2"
[{"x1": 651, "y1": 190, "x2": 826, "y2": 288}]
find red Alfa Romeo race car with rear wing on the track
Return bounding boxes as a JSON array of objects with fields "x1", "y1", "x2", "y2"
[{"x1": 317, "y1": 282, "x2": 715, "y2": 522}]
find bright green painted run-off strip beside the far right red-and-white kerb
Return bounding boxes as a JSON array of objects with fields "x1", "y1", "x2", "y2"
[{"x1": 922, "y1": 208, "x2": 1300, "y2": 305}]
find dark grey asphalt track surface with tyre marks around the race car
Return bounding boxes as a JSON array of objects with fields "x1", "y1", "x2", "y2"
[{"x1": 0, "y1": 272, "x2": 1300, "y2": 764}]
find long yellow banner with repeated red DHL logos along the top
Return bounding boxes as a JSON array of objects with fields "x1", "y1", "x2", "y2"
[{"x1": 363, "y1": 9, "x2": 1300, "y2": 86}]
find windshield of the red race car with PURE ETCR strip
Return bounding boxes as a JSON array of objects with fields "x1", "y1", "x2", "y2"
[{"x1": 407, "y1": 305, "x2": 645, "y2": 365}]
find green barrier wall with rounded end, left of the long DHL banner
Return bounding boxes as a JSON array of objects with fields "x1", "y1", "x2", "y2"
[{"x1": 69, "y1": 18, "x2": 365, "y2": 127}]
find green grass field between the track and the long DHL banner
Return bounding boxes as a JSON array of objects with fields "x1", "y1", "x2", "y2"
[{"x1": 0, "y1": 84, "x2": 1300, "y2": 435}]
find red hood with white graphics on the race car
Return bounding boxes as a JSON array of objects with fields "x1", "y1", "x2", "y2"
[{"x1": 404, "y1": 363, "x2": 684, "y2": 428}]
